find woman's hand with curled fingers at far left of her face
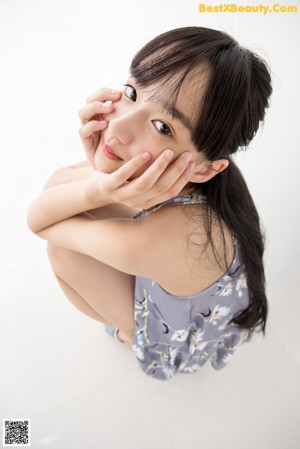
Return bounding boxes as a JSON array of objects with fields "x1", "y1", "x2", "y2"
[{"x1": 79, "y1": 88, "x2": 121, "y2": 167}]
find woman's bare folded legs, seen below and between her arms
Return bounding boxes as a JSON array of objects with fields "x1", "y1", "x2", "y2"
[{"x1": 48, "y1": 204, "x2": 137, "y2": 343}]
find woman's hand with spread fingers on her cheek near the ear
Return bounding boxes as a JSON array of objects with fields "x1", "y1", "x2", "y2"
[{"x1": 87, "y1": 150, "x2": 194, "y2": 209}]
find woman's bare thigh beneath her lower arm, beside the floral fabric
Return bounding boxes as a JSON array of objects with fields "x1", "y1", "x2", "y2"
[{"x1": 48, "y1": 244, "x2": 135, "y2": 335}]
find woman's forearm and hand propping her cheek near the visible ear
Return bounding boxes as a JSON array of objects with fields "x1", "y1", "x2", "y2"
[{"x1": 28, "y1": 151, "x2": 191, "y2": 234}]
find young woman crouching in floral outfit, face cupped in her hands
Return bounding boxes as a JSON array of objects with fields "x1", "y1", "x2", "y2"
[{"x1": 28, "y1": 27, "x2": 272, "y2": 380}]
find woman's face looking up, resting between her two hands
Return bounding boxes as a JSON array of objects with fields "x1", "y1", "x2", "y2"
[{"x1": 94, "y1": 70, "x2": 209, "y2": 177}]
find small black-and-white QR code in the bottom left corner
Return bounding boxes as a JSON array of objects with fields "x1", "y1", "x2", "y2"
[{"x1": 3, "y1": 419, "x2": 30, "y2": 447}]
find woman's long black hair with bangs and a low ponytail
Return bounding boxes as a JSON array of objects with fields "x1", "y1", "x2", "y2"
[{"x1": 130, "y1": 27, "x2": 272, "y2": 338}]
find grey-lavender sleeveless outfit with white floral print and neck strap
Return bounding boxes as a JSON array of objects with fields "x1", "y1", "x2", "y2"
[{"x1": 133, "y1": 194, "x2": 249, "y2": 380}]
